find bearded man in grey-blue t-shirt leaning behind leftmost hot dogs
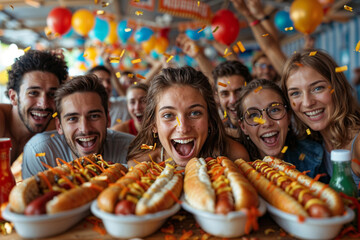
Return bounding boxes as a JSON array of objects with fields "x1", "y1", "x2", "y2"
[{"x1": 22, "y1": 74, "x2": 134, "y2": 179}]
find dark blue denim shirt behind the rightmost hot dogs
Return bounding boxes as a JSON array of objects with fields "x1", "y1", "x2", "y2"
[{"x1": 284, "y1": 139, "x2": 330, "y2": 183}]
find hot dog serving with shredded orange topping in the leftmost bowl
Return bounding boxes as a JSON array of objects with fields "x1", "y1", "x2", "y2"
[{"x1": 9, "y1": 154, "x2": 127, "y2": 215}]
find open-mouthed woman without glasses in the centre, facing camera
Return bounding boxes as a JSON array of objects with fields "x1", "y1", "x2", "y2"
[{"x1": 128, "y1": 67, "x2": 249, "y2": 167}]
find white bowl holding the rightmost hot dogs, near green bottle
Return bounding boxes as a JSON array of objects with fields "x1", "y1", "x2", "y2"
[{"x1": 266, "y1": 202, "x2": 355, "y2": 240}]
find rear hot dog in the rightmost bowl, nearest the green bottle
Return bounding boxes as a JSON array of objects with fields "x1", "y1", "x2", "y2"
[{"x1": 263, "y1": 156, "x2": 345, "y2": 216}]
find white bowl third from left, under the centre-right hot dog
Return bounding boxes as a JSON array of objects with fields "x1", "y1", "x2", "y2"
[{"x1": 181, "y1": 197, "x2": 266, "y2": 238}]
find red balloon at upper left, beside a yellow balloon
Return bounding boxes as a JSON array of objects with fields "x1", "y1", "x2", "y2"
[{"x1": 46, "y1": 7, "x2": 72, "y2": 35}]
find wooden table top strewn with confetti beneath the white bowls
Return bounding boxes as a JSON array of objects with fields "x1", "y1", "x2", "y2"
[{"x1": 0, "y1": 209, "x2": 356, "y2": 240}]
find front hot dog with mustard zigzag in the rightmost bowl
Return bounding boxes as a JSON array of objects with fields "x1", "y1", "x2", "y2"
[{"x1": 235, "y1": 159, "x2": 344, "y2": 218}]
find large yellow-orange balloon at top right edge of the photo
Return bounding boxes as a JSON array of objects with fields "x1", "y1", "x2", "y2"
[{"x1": 290, "y1": 0, "x2": 324, "y2": 34}]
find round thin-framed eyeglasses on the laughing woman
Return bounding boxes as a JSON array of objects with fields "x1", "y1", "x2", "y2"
[{"x1": 240, "y1": 103, "x2": 287, "y2": 126}]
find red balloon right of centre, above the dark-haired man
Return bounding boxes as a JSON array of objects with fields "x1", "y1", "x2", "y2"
[{"x1": 211, "y1": 9, "x2": 240, "y2": 45}]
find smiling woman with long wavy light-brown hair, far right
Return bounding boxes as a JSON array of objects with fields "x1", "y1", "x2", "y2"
[{"x1": 281, "y1": 50, "x2": 360, "y2": 185}]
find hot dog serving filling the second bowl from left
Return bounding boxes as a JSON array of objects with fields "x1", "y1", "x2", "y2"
[{"x1": 97, "y1": 162, "x2": 183, "y2": 215}]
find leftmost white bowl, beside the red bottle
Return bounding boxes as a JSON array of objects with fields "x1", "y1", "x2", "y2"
[{"x1": 2, "y1": 202, "x2": 91, "y2": 238}]
